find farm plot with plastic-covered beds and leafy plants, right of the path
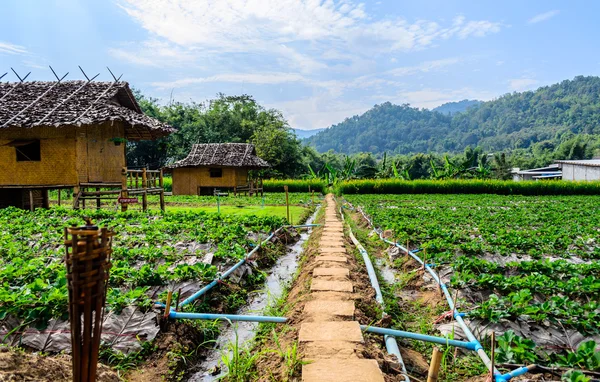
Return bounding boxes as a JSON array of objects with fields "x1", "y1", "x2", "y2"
[{"x1": 345, "y1": 195, "x2": 600, "y2": 370}]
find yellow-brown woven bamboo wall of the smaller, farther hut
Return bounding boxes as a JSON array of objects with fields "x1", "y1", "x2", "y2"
[{"x1": 173, "y1": 167, "x2": 248, "y2": 195}]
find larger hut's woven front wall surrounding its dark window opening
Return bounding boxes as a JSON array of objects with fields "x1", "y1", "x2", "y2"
[{"x1": 0, "y1": 127, "x2": 77, "y2": 186}]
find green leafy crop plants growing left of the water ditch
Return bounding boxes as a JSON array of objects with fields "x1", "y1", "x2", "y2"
[{"x1": 0, "y1": 208, "x2": 284, "y2": 323}]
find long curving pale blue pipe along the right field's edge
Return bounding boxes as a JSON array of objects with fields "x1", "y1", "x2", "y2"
[{"x1": 350, "y1": 203, "x2": 504, "y2": 381}]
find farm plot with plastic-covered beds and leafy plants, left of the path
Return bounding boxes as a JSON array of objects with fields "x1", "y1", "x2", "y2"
[{"x1": 0, "y1": 208, "x2": 285, "y2": 353}]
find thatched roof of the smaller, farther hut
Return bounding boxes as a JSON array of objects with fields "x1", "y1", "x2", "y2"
[{"x1": 169, "y1": 143, "x2": 270, "y2": 169}]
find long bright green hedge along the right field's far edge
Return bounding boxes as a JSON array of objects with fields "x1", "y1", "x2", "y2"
[{"x1": 335, "y1": 179, "x2": 600, "y2": 195}]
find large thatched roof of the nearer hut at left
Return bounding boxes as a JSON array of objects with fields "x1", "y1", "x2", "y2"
[{"x1": 0, "y1": 81, "x2": 174, "y2": 140}]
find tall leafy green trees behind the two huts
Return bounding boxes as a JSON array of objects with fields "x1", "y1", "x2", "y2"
[{"x1": 127, "y1": 92, "x2": 304, "y2": 177}]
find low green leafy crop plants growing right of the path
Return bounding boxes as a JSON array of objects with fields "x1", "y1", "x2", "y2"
[{"x1": 345, "y1": 195, "x2": 600, "y2": 335}]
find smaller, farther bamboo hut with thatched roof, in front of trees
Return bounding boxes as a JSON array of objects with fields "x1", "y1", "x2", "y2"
[{"x1": 169, "y1": 143, "x2": 270, "y2": 195}]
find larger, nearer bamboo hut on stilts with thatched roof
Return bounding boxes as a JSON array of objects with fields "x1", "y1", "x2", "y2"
[{"x1": 0, "y1": 81, "x2": 173, "y2": 209}]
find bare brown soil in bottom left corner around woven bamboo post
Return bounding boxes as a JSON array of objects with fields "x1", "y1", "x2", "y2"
[{"x1": 0, "y1": 347, "x2": 120, "y2": 382}]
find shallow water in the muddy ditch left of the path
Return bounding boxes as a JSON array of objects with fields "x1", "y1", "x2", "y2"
[{"x1": 188, "y1": 212, "x2": 316, "y2": 382}]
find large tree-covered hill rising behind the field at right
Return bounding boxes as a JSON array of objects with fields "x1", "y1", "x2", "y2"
[{"x1": 305, "y1": 76, "x2": 600, "y2": 154}]
